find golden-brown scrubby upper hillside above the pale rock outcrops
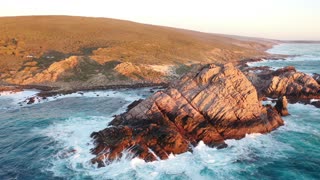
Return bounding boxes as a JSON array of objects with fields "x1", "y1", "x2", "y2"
[{"x1": 0, "y1": 16, "x2": 273, "y2": 87}]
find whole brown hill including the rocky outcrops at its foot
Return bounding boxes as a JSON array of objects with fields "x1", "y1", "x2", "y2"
[{"x1": 0, "y1": 16, "x2": 276, "y2": 89}]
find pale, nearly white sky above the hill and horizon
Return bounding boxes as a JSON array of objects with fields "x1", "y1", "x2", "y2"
[{"x1": 0, "y1": 0, "x2": 320, "y2": 40}]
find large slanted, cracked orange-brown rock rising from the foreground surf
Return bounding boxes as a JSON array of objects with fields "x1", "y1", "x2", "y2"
[{"x1": 91, "y1": 63, "x2": 283, "y2": 166}]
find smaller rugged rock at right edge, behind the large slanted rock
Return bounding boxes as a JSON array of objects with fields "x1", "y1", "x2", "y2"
[{"x1": 245, "y1": 66, "x2": 320, "y2": 100}]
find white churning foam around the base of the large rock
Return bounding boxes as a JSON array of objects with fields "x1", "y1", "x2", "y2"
[{"x1": 33, "y1": 90, "x2": 319, "y2": 179}]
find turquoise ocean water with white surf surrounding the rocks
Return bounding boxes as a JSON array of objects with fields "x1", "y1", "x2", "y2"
[{"x1": 0, "y1": 44, "x2": 320, "y2": 180}]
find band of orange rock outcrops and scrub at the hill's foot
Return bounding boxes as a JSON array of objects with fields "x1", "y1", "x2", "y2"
[{"x1": 0, "y1": 56, "x2": 172, "y2": 90}]
